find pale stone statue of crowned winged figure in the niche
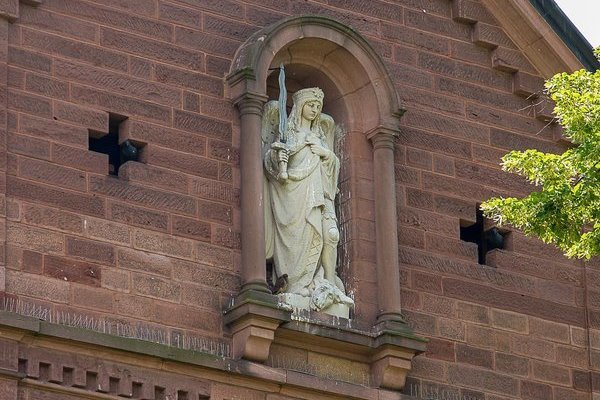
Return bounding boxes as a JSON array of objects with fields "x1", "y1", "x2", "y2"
[{"x1": 262, "y1": 88, "x2": 354, "y2": 318}]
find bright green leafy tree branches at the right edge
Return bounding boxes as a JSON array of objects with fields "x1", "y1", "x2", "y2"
[{"x1": 481, "y1": 48, "x2": 600, "y2": 259}]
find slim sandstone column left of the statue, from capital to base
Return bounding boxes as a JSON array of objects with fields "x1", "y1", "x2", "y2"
[{"x1": 235, "y1": 92, "x2": 270, "y2": 293}]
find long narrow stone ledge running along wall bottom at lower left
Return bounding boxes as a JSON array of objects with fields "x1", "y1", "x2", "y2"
[{"x1": 0, "y1": 311, "x2": 412, "y2": 400}]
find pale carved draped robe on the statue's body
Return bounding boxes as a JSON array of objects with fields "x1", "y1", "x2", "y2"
[{"x1": 264, "y1": 131, "x2": 340, "y2": 296}]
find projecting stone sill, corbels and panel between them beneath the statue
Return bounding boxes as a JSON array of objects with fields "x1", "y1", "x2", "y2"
[{"x1": 224, "y1": 290, "x2": 427, "y2": 390}]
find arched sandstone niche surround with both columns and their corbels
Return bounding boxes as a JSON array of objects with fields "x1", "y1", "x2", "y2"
[{"x1": 225, "y1": 16, "x2": 424, "y2": 378}]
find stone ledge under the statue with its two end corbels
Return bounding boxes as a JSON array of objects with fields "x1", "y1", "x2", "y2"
[{"x1": 224, "y1": 290, "x2": 427, "y2": 390}]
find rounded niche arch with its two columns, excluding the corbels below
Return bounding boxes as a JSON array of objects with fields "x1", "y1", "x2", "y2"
[{"x1": 227, "y1": 16, "x2": 403, "y2": 332}]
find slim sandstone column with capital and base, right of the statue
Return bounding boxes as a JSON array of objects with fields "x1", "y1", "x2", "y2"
[{"x1": 367, "y1": 127, "x2": 403, "y2": 323}]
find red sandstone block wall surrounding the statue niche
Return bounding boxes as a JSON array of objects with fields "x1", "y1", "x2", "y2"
[{"x1": 6, "y1": 0, "x2": 600, "y2": 400}]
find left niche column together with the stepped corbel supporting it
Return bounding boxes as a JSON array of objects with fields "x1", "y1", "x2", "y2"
[{"x1": 223, "y1": 90, "x2": 291, "y2": 362}]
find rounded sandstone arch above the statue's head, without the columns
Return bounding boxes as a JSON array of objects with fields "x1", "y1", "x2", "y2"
[{"x1": 227, "y1": 16, "x2": 403, "y2": 133}]
